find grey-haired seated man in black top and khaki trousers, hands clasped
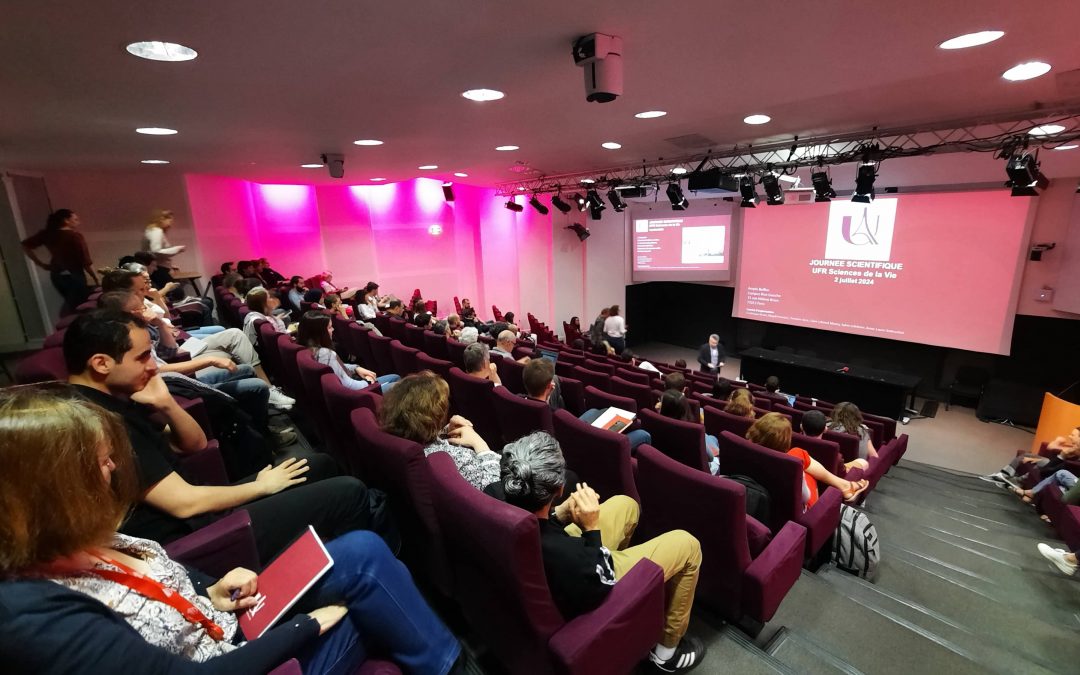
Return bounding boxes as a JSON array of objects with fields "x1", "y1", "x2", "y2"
[{"x1": 500, "y1": 431, "x2": 705, "y2": 673}]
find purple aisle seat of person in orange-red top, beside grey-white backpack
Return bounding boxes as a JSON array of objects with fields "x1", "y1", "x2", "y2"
[{"x1": 719, "y1": 431, "x2": 843, "y2": 558}]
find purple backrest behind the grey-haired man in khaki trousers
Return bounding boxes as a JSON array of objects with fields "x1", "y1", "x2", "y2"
[{"x1": 429, "y1": 444, "x2": 564, "y2": 673}]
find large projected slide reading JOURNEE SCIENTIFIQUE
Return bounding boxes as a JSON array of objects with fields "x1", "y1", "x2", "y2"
[{"x1": 734, "y1": 191, "x2": 1032, "y2": 354}]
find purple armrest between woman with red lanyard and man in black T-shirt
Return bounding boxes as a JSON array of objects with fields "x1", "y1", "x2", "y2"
[{"x1": 165, "y1": 510, "x2": 262, "y2": 579}]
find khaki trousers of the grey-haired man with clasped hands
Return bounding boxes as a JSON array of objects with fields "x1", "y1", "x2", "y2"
[{"x1": 566, "y1": 495, "x2": 701, "y2": 647}]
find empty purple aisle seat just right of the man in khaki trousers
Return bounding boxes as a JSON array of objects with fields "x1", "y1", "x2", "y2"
[{"x1": 636, "y1": 444, "x2": 806, "y2": 623}]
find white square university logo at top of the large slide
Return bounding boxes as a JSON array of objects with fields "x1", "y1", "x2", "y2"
[{"x1": 825, "y1": 199, "x2": 896, "y2": 261}]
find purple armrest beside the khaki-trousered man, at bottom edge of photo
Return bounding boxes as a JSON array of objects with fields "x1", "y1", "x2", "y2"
[{"x1": 548, "y1": 559, "x2": 664, "y2": 674}]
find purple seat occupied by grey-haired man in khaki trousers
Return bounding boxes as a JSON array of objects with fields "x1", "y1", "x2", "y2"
[{"x1": 429, "y1": 454, "x2": 664, "y2": 674}]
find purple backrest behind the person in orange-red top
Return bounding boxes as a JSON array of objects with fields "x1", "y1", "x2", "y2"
[{"x1": 719, "y1": 431, "x2": 804, "y2": 534}]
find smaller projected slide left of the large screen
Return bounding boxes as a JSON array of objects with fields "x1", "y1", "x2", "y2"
[{"x1": 634, "y1": 215, "x2": 731, "y2": 281}]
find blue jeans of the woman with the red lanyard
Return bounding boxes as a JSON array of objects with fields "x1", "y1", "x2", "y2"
[{"x1": 297, "y1": 530, "x2": 461, "y2": 675}]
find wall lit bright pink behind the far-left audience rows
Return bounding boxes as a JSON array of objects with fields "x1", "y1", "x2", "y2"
[{"x1": 187, "y1": 176, "x2": 554, "y2": 324}]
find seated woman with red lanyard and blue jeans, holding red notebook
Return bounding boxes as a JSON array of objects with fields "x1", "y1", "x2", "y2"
[{"x1": 0, "y1": 387, "x2": 460, "y2": 674}]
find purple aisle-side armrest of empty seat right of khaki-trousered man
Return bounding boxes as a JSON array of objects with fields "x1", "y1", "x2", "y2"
[{"x1": 742, "y1": 522, "x2": 806, "y2": 622}]
